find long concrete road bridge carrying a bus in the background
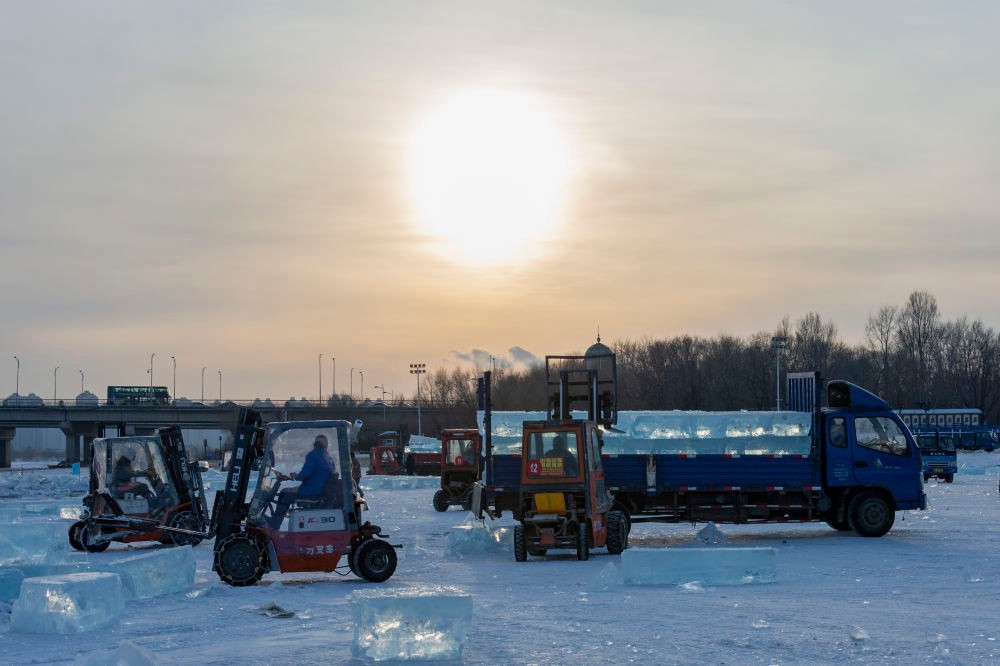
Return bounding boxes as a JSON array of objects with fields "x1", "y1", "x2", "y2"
[{"x1": 0, "y1": 401, "x2": 476, "y2": 468}]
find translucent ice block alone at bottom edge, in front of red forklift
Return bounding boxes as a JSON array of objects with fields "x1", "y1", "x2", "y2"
[{"x1": 348, "y1": 586, "x2": 472, "y2": 661}]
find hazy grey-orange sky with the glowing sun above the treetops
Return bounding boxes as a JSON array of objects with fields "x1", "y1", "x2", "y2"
[{"x1": 0, "y1": 0, "x2": 1000, "y2": 399}]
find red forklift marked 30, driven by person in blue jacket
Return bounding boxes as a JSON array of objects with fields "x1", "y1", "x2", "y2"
[{"x1": 212, "y1": 409, "x2": 398, "y2": 587}]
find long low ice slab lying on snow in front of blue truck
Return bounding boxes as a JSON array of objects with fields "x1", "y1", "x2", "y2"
[{"x1": 621, "y1": 548, "x2": 778, "y2": 585}]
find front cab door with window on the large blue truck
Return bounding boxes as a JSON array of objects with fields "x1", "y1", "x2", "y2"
[{"x1": 848, "y1": 412, "x2": 921, "y2": 501}]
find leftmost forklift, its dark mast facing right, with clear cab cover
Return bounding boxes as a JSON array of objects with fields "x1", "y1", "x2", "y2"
[{"x1": 69, "y1": 426, "x2": 211, "y2": 553}]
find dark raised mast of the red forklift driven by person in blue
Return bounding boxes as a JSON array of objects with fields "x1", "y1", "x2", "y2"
[{"x1": 212, "y1": 407, "x2": 264, "y2": 543}]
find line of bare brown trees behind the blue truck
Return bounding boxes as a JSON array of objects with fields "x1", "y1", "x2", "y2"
[{"x1": 414, "y1": 291, "x2": 1000, "y2": 423}]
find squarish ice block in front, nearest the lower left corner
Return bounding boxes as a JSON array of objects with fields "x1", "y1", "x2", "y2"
[{"x1": 10, "y1": 571, "x2": 125, "y2": 634}]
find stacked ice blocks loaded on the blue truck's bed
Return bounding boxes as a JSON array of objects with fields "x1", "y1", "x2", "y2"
[{"x1": 478, "y1": 411, "x2": 812, "y2": 455}]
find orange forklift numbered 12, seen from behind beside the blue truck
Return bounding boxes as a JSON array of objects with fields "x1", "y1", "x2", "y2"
[{"x1": 514, "y1": 345, "x2": 628, "y2": 562}]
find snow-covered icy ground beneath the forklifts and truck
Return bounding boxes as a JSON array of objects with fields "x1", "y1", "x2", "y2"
[{"x1": 0, "y1": 452, "x2": 1000, "y2": 664}]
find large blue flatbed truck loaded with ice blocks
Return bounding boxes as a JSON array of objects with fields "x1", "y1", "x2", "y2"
[{"x1": 474, "y1": 373, "x2": 927, "y2": 537}]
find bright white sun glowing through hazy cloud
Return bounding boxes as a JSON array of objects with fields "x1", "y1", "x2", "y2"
[{"x1": 409, "y1": 89, "x2": 571, "y2": 264}]
